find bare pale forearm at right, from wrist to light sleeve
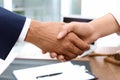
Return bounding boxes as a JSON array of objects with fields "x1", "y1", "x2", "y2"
[{"x1": 89, "y1": 13, "x2": 120, "y2": 38}]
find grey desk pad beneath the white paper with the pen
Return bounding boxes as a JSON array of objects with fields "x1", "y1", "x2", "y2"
[{"x1": 0, "y1": 58, "x2": 91, "y2": 80}]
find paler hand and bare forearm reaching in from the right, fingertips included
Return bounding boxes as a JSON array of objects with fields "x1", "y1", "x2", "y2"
[{"x1": 51, "y1": 12, "x2": 120, "y2": 60}]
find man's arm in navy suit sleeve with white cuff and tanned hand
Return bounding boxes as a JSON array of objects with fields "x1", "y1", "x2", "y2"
[{"x1": 0, "y1": 7, "x2": 89, "y2": 60}]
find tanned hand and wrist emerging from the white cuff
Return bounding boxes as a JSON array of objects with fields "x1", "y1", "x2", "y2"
[{"x1": 25, "y1": 20, "x2": 89, "y2": 60}]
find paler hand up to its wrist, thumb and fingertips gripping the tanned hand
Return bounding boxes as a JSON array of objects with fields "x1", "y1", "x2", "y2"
[{"x1": 51, "y1": 22, "x2": 98, "y2": 60}]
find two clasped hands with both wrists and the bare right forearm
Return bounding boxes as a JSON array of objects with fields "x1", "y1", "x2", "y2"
[{"x1": 25, "y1": 14, "x2": 120, "y2": 61}]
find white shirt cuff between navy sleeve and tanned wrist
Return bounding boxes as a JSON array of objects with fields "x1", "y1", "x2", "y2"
[{"x1": 18, "y1": 18, "x2": 31, "y2": 42}]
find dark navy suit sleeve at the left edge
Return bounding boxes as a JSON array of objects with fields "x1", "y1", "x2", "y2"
[{"x1": 0, "y1": 7, "x2": 26, "y2": 60}]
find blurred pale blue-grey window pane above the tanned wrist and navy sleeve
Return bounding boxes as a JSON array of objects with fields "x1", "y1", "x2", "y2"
[{"x1": 12, "y1": 0, "x2": 61, "y2": 21}]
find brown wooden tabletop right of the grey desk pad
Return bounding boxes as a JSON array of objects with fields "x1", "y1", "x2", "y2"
[{"x1": 77, "y1": 57, "x2": 120, "y2": 80}]
